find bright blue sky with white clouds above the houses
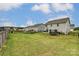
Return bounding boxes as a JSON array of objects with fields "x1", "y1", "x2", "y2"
[{"x1": 0, "y1": 3, "x2": 79, "y2": 27}]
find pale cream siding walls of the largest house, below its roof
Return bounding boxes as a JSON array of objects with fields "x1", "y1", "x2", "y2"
[{"x1": 47, "y1": 21, "x2": 70, "y2": 34}]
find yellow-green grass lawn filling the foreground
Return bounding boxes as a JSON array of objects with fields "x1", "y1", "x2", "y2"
[{"x1": 0, "y1": 32, "x2": 79, "y2": 56}]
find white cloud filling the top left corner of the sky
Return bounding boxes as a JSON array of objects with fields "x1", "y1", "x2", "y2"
[{"x1": 0, "y1": 3, "x2": 22, "y2": 11}]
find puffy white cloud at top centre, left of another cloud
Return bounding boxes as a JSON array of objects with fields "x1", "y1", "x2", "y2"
[{"x1": 32, "y1": 4, "x2": 51, "y2": 13}]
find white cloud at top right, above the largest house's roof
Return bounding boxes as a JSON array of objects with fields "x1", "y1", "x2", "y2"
[{"x1": 51, "y1": 3, "x2": 74, "y2": 12}]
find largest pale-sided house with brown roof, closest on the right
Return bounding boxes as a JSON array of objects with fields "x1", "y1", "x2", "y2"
[{"x1": 46, "y1": 17, "x2": 70, "y2": 34}]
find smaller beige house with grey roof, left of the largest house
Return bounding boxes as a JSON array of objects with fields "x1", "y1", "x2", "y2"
[{"x1": 25, "y1": 23, "x2": 46, "y2": 32}]
